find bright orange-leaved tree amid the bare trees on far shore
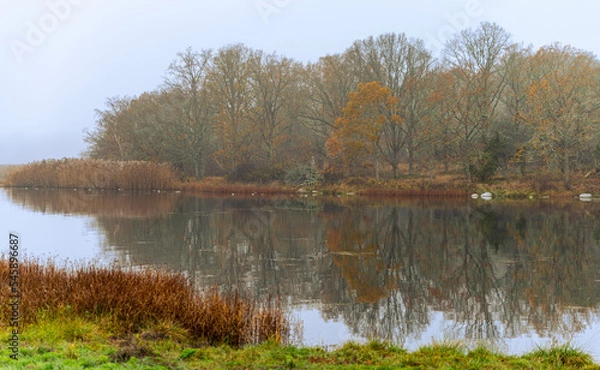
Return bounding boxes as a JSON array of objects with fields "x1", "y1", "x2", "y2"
[{"x1": 327, "y1": 82, "x2": 404, "y2": 179}]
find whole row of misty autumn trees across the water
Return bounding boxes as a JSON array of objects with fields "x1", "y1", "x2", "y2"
[{"x1": 86, "y1": 23, "x2": 600, "y2": 187}]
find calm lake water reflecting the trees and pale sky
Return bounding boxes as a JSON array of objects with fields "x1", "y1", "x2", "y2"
[{"x1": 0, "y1": 189, "x2": 600, "y2": 362}]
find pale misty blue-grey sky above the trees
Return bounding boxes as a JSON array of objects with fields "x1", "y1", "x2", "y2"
[{"x1": 0, "y1": 0, "x2": 600, "y2": 164}]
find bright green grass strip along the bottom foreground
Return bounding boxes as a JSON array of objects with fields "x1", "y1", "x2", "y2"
[{"x1": 0, "y1": 315, "x2": 600, "y2": 369}]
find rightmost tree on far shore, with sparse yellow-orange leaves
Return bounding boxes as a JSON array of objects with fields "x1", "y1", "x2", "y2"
[{"x1": 527, "y1": 45, "x2": 600, "y2": 189}]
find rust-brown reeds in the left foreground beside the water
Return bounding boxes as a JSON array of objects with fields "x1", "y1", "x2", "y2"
[{"x1": 0, "y1": 257, "x2": 289, "y2": 346}]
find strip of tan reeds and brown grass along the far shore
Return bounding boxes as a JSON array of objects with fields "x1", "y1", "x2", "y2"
[{"x1": 5, "y1": 159, "x2": 600, "y2": 199}]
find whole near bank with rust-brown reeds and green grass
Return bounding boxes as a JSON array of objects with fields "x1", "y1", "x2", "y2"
[{"x1": 0, "y1": 259, "x2": 600, "y2": 369}]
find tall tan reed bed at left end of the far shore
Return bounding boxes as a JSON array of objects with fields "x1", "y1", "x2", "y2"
[{"x1": 6, "y1": 158, "x2": 178, "y2": 190}]
